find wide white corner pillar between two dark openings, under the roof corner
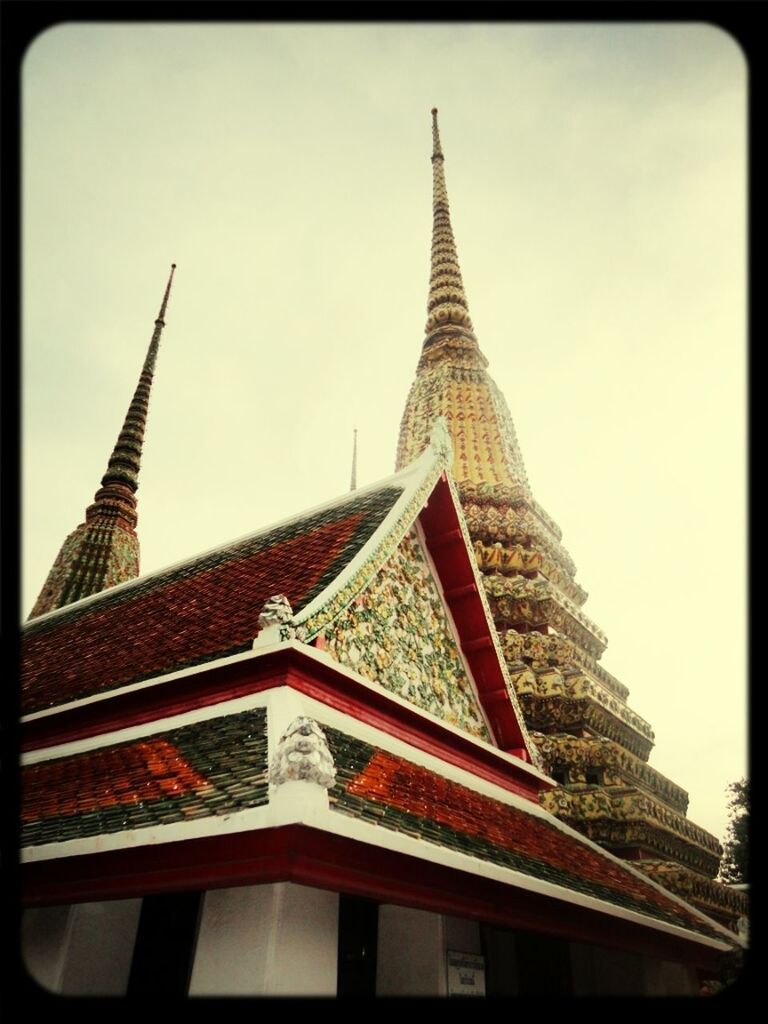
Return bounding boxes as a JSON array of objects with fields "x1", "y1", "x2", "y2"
[{"x1": 189, "y1": 882, "x2": 339, "y2": 995}]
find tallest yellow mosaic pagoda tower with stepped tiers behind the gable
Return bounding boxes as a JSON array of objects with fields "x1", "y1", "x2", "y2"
[{"x1": 397, "y1": 110, "x2": 745, "y2": 927}]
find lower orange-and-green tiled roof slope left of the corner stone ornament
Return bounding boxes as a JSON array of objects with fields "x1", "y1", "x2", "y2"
[{"x1": 22, "y1": 708, "x2": 268, "y2": 847}]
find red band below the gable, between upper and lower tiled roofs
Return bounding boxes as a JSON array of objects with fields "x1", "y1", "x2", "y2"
[{"x1": 20, "y1": 647, "x2": 547, "y2": 803}]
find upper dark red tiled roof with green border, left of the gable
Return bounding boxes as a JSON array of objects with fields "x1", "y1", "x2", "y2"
[{"x1": 22, "y1": 484, "x2": 401, "y2": 714}]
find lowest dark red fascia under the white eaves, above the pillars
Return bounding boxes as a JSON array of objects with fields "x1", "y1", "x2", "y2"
[{"x1": 20, "y1": 824, "x2": 722, "y2": 969}]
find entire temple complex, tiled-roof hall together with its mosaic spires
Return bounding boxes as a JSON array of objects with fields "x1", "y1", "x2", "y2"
[{"x1": 20, "y1": 112, "x2": 739, "y2": 996}]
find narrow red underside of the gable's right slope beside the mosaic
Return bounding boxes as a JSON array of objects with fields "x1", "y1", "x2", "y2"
[{"x1": 419, "y1": 474, "x2": 529, "y2": 760}]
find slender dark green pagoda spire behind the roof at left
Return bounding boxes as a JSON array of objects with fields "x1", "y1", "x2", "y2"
[{"x1": 30, "y1": 263, "x2": 176, "y2": 618}]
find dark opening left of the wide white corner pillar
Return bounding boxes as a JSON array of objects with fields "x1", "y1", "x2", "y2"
[{"x1": 127, "y1": 893, "x2": 202, "y2": 995}]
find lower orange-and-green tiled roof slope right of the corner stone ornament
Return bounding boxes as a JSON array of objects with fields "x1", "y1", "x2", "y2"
[{"x1": 323, "y1": 726, "x2": 722, "y2": 939}]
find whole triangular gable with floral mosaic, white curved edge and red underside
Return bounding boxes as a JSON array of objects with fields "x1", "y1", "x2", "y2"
[{"x1": 280, "y1": 419, "x2": 541, "y2": 766}]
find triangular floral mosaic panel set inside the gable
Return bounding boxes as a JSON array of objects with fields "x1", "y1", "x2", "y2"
[{"x1": 325, "y1": 529, "x2": 489, "y2": 740}]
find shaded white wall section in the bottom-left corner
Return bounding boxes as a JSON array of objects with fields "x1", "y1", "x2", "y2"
[{"x1": 22, "y1": 899, "x2": 141, "y2": 995}]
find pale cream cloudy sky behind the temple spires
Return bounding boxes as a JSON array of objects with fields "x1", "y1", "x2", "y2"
[{"x1": 23, "y1": 24, "x2": 746, "y2": 851}]
